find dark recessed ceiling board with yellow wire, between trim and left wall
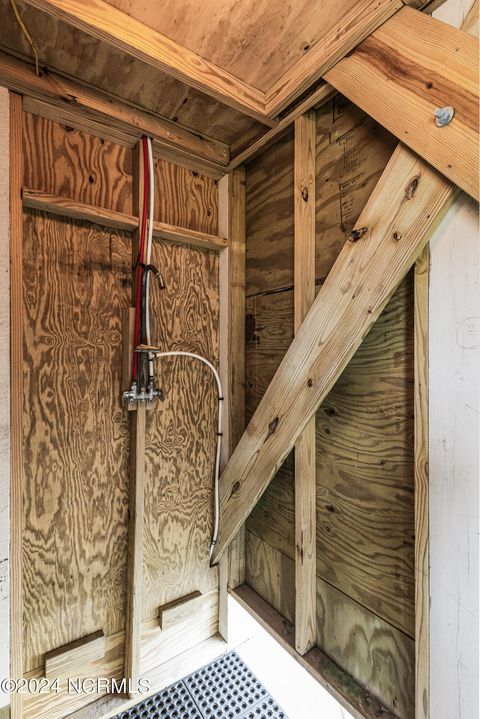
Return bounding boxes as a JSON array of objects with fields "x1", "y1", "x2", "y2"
[{"x1": 0, "y1": 0, "x2": 261, "y2": 144}]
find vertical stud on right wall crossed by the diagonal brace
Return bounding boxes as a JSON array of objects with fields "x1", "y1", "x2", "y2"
[{"x1": 294, "y1": 110, "x2": 316, "y2": 655}]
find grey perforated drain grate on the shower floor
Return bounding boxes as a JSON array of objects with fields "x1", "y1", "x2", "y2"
[{"x1": 116, "y1": 652, "x2": 288, "y2": 719}]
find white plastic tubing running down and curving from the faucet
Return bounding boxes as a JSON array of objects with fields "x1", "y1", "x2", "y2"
[{"x1": 145, "y1": 137, "x2": 223, "y2": 559}]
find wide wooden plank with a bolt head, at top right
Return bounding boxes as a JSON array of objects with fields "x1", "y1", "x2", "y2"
[{"x1": 325, "y1": 7, "x2": 479, "y2": 200}]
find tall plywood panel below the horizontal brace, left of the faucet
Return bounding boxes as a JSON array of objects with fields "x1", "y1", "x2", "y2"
[{"x1": 23, "y1": 210, "x2": 131, "y2": 671}]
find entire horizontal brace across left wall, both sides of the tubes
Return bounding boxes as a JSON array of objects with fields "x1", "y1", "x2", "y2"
[{"x1": 22, "y1": 187, "x2": 228, "y2": 252}]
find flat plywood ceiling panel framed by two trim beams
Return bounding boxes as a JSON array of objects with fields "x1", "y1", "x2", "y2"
[{"x1": 107, "y1": 0, "x2": 355, "y2": 91}]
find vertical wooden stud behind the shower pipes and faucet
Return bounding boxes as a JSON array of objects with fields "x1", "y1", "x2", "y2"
[{"x1": 125, "y1": 142, "x2": 146, "y2": 691}]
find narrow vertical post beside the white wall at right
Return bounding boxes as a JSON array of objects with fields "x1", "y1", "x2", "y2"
[{"x1": 414, "y1": 245, "x2": 430, "y2": 719}]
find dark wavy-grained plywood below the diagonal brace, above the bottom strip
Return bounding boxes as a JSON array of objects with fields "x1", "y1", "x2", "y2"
[{"x1": 247, "y1": 276, "x2": 415, "y2": 637}]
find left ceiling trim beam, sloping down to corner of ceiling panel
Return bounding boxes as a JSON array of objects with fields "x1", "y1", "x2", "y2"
[{"x1": 23, "y1": 0, "x2": 271, "y2": 124}]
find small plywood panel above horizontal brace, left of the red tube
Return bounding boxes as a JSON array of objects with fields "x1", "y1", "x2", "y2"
[{"x1": 23, "y1": 113, "x2": 132, "y2": 215}]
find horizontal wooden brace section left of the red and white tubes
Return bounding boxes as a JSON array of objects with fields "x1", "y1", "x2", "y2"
[{"x1": 22, "y1": 187, "x2": 138, "y2": 232}]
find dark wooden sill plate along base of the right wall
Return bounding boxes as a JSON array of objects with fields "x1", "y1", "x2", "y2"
[{"x1": 231, "y1": 584, "x2": 395, "y2": 719}]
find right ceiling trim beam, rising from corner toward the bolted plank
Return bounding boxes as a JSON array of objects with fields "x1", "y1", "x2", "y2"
[{"x1": 265, "y1": 0, "x2": 403, "y2": 117}]
